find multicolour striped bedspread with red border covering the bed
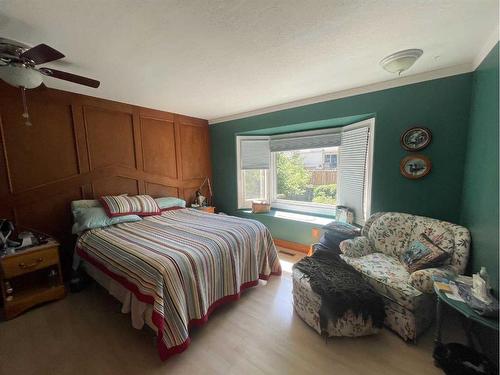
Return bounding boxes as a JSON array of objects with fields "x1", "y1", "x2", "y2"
[{"x1": 76, "y1": 209, "x2": 281, "y2": 360}]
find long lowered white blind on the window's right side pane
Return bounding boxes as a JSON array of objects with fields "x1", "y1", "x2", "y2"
[{"x1": 338, "y1": 126, "x2": 370, "y2": 224}]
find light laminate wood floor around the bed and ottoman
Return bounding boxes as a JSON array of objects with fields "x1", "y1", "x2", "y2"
[{"x1": 0, "y1": 253, "x2": 454, "y2": 375}]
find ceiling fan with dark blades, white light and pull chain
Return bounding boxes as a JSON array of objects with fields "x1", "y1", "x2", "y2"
[{"x1": 0, "y1": 38, "x2": 100, "y2": 126}]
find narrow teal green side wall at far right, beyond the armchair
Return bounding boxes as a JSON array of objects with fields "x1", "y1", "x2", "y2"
[{"x1": 462, "y1": 44, "x2": 499, "y2": 290}]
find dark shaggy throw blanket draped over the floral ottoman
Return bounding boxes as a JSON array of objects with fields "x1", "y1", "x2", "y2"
[{"x1": 293, "y1": 251, "x2": 385, "y2": 332}]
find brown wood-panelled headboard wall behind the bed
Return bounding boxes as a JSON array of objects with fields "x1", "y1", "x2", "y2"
[{"x1": 0, "y1": 81, "x2": 211, "y2": 270}]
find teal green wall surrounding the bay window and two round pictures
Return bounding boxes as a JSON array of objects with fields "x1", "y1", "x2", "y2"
[{"x1": 210, "y1": 74, "x2": 472, "y2": 244}]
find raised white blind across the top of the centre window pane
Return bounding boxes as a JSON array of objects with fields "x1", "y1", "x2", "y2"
[{"x1": 270, "y1": 129, "x2": 341, "y2": 152}]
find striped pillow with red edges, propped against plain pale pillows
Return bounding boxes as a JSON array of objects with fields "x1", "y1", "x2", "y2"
[{"x1": 99, "y1": 195, "x2": 161, "y2": 217}]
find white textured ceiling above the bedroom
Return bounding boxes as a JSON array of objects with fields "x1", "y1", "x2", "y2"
[{"x1": 0, "y1": 0, "x2": 499, "y2": 119}]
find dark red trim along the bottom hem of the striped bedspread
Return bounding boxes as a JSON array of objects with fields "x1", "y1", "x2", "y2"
[{"x1": 76, "y1": 247, "x2": 281, "y2": 361}]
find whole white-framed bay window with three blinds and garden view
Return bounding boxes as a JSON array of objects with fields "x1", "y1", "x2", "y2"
[{"x1": 237, "y1": 120, "x2": 373, "y2": 223}]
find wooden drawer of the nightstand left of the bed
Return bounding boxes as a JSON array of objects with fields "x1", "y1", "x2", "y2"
[{"x1": 1, "y1": 247, "x2": 59, "y2": 279}]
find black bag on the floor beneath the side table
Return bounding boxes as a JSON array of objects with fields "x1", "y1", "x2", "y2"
[{"x1": 433, "y1": 343, "x2": 498, "y2": 375}]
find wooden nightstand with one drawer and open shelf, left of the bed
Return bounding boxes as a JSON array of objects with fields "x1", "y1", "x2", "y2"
[{"x1": 0, "y1": 240, "x2": 66, "y2": 319}]
